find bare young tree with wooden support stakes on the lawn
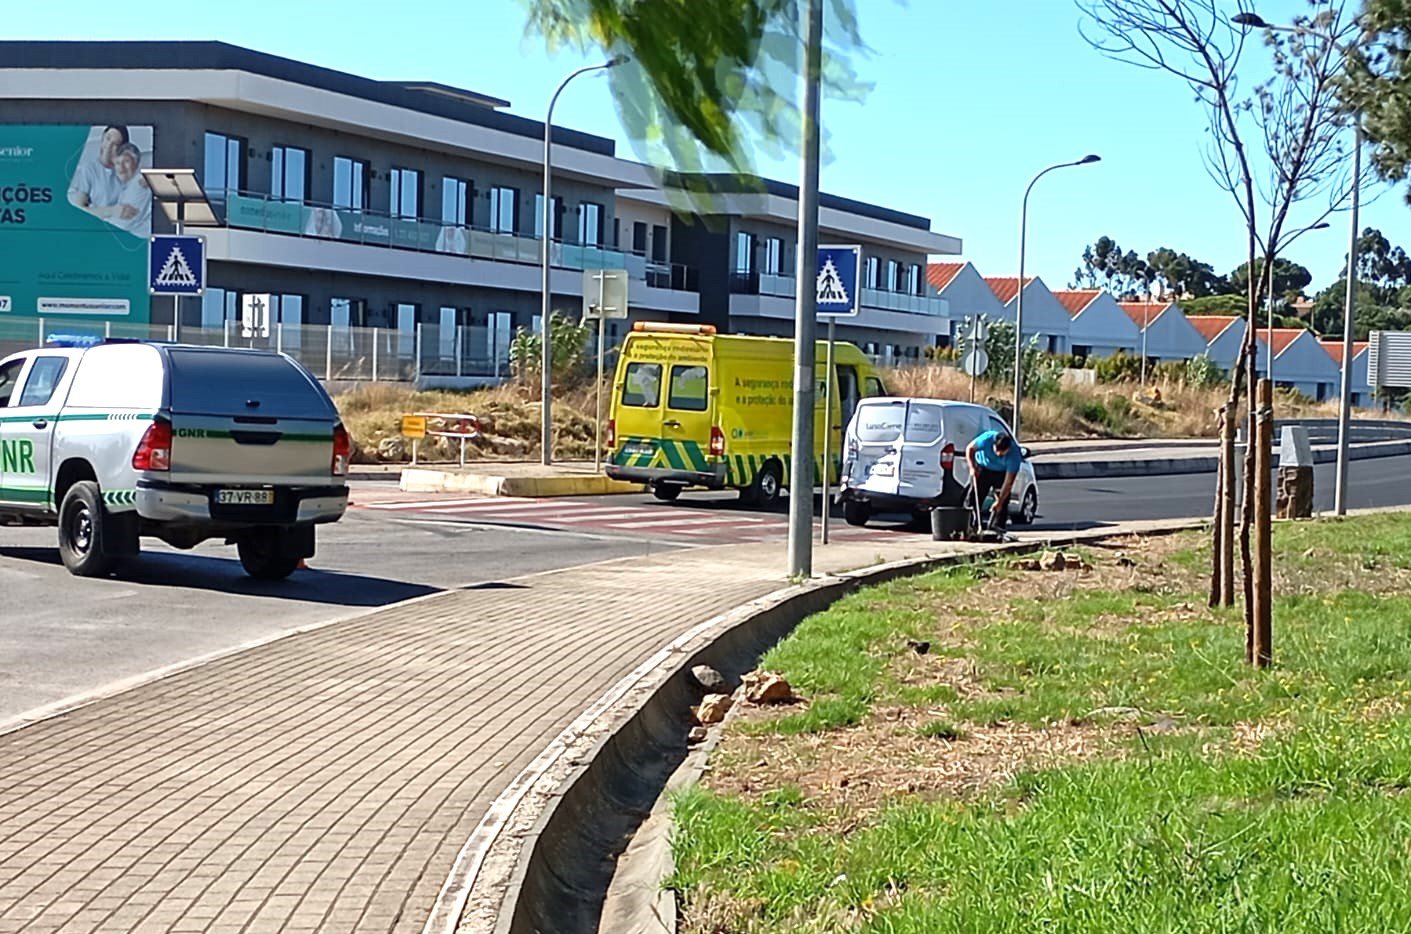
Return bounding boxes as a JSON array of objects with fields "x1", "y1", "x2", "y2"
[{"x1": 1077, "y1": 0, "x2": 1355, "y2": 662}]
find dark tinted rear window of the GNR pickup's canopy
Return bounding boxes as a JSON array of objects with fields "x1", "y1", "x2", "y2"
[{"x1": 171, "y1": 350, "x2": 333, "y2": 418}]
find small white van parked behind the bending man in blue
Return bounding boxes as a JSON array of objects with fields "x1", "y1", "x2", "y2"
[{"x1": 841, "y1": 396, "x2": 1038, "y2": 525}]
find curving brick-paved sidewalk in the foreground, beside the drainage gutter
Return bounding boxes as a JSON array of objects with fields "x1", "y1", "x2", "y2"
[{"x1": 0, "y1": 539, "x2": 1004, "y2": 934}]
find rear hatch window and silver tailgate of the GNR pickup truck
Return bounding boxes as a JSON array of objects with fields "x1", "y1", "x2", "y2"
[{"x1": 166, "y1": 347, "x2": 337, "y2": 487}]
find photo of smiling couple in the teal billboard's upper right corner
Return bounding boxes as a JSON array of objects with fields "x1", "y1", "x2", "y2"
[{"x1": 68, "y1": 126, "x2": 152, "y2": 240}]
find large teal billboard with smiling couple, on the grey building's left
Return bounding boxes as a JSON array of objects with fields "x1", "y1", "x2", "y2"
[{"x1": 0, "y1": 124, "x2": 152, "y2": 329}]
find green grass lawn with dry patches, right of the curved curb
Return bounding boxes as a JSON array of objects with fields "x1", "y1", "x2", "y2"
[{"x1": 672, "y1": 515, "x2": 1411, "y2": 934}]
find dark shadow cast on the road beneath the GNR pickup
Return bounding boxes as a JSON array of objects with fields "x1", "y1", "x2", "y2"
[{"x1": 0, "y1": 546, "x2": 442, "y2": 607}]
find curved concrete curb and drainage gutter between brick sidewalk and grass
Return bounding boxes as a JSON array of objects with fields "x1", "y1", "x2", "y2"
[{"x1": 448, "y1": 519, "x2": 1205, "y2": 934}]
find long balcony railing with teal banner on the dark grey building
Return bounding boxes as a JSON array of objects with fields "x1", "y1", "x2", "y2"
[{"x1": 212, "y1": 192, "x2": 700, "y2": 292}]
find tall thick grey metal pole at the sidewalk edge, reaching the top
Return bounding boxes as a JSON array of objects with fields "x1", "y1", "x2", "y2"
[{"x1": 789, "y1": 0, "x2": 827, "y2": 577}]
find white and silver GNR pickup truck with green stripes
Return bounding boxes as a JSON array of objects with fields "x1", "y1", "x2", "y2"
[{"x1": 0, "y1": 340, "x2": 351, "y2": 580}]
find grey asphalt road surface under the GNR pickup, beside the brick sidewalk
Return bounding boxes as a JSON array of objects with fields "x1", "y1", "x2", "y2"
[{"x1": 0, "y1": 487, "x2": 677, "y2": 727}]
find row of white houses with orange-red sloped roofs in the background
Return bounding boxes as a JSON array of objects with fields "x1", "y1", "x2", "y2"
[{"x1": 927, "y1": 262, "x2": 1371, "y2": 406}]
